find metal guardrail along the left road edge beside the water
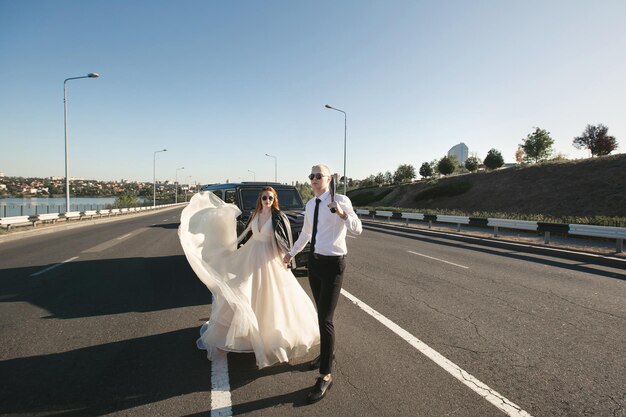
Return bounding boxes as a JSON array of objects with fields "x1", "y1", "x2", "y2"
[{"x1": 0, "y1": 203, "x2": 187, "y2": 230}]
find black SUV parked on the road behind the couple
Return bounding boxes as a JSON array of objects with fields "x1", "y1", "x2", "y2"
[{"x1": 200, "y1": 182, "x2": 309, "y2": 268}]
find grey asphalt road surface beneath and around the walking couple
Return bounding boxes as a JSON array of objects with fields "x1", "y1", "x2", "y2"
[{"x1": 0, "y1": 208, "x2": 626, "y2": 417}]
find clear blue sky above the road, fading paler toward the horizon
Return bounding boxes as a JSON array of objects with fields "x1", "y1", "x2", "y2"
[{"x1": 0, "y1": 0, "x2": 626, "y2": 183}]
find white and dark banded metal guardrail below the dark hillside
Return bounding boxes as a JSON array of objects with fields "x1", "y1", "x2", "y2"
[{"x1": 356, "y1": 209, "x2": 626, "y2": 253}]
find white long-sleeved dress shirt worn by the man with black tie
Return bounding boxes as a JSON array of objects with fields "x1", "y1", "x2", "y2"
[{"x1": 289, "y1": 191, "x2": 363, "y2": 257}]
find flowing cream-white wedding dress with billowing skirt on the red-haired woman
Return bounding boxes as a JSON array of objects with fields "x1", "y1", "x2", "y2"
[{"x1": 178, "y1": 192, "x2": 319, "y2": 368}]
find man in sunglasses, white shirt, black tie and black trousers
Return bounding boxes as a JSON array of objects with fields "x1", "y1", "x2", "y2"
[{"x1": 283, "y1": 165, "x2": 363, "y2": 403}]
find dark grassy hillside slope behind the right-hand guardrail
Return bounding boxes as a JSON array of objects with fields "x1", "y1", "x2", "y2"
[{"x1": 348, "y1": 154, "x2": 626, "y2": 224}]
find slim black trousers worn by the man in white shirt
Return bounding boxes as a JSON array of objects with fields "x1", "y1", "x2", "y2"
[{"x1": 309, "y1": 255, "x2": 346, "y2": 375}]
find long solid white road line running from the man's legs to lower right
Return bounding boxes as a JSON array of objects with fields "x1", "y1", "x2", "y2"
[{"x1": 341, "y1": 289, "x2": 532, "y2": 417}]
